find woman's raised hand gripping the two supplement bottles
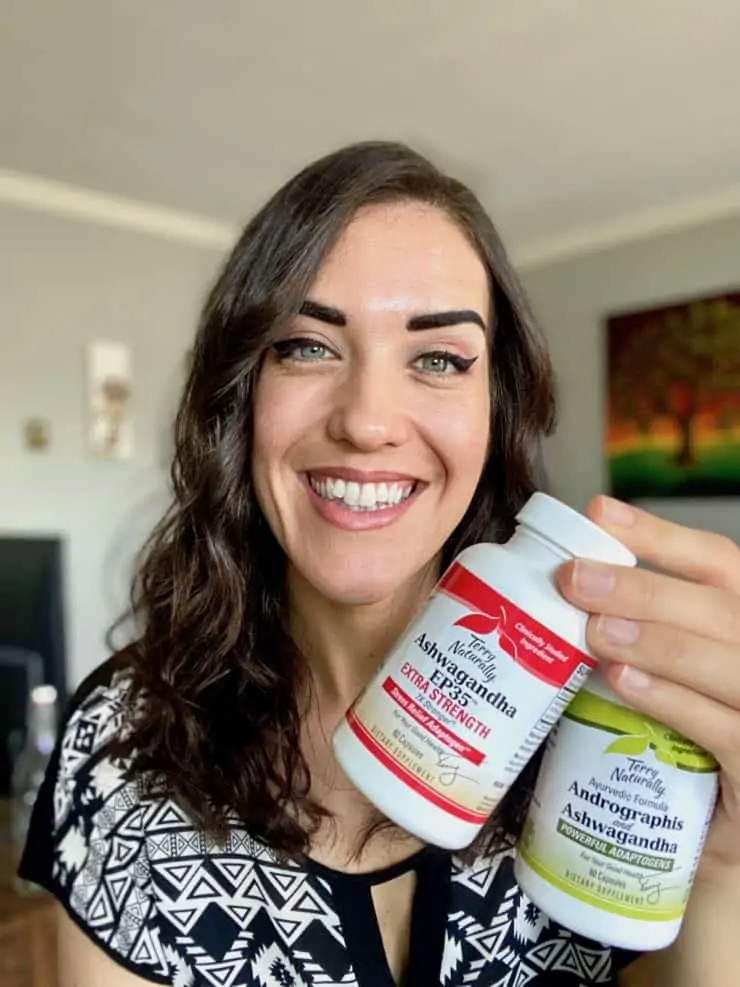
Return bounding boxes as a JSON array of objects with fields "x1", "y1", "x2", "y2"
[{"x1": 559, "y1": 497, "x2": 740, "y2": 890}]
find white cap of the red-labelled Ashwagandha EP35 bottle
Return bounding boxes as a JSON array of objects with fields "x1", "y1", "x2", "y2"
[{"x1": 516, "y1": 492, "x2": 637, "y2": 566}]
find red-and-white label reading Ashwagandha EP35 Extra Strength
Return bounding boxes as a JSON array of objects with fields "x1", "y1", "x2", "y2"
[{"x1": 347, "y1": 562, "x2": 594, "y2": 825}]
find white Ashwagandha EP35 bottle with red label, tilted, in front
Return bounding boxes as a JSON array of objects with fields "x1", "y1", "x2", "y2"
[{"x1": 333, "y1": 493, "x2": 635, "y2": 850}]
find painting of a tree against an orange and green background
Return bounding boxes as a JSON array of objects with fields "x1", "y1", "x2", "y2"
[{"x1": 606, "y1": 291, "x2": 740, "y2": 500}]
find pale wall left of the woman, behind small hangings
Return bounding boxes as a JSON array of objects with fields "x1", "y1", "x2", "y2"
[{"x1": 0, "y1": 206, "x2": 220, "y2": 684}]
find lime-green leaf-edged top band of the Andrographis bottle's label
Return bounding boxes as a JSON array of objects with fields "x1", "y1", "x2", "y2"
[{"x1": 563, "y1": 689, "x2": 718, "y2": 772}]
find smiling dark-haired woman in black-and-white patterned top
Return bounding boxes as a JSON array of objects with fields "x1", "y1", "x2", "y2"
[{"x1": 22, "y1": 143, "x2": 740, "y2": 987}]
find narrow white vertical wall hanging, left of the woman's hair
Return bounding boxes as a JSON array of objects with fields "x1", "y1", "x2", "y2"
[{"x1": 88, "y1": 342, "x2": 134, "y2": 459}]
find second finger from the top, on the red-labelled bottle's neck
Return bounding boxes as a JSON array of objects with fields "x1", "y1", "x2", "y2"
[{"x1": 558, "y1": 559, "x2": 740, "y2": 649}]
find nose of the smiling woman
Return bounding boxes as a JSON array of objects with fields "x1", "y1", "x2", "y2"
[{"x1": 328, "y1": 367, "x2": 409, "y2": 452}]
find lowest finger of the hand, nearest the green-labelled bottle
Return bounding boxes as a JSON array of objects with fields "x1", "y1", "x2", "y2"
[{"x1": 604, "y1": 663, "x2": 740, "y2": 787}]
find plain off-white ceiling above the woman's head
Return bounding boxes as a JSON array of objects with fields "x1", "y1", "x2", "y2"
[{"x1": 0, "y1": 0, "x2": 740, "y2": 261}]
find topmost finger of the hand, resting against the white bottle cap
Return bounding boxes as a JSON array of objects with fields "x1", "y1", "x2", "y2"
[{"x1": 588, "y1": 496, "x2": 740, "y2": 594}]
